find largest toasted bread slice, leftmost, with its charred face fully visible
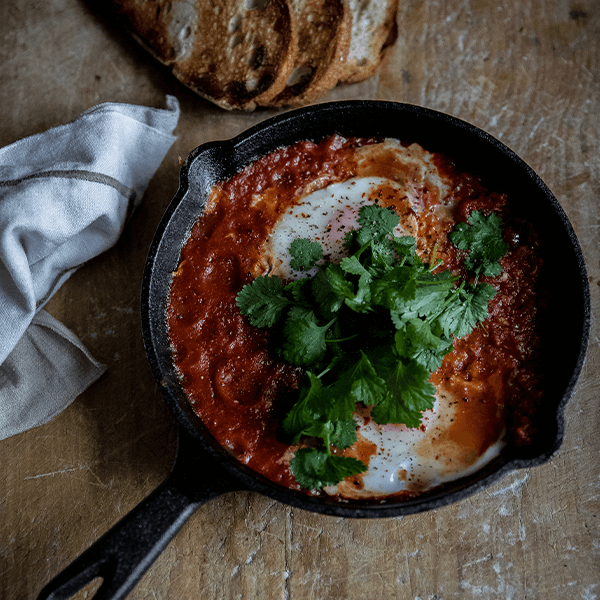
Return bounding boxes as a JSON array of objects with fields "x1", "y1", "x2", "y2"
[{"x1": 112, "y1": 0, "x2": 298, "y2": 110}]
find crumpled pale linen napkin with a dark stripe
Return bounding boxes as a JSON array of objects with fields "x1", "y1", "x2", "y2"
[{"x1": 0, "y1": 96, "x2": 179, "y2": 439}]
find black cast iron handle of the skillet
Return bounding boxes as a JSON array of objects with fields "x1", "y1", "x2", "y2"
[{"x1": 38, "y1": 434, "x2": 244, "y2": 600}]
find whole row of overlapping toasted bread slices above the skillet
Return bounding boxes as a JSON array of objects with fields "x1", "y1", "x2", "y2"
[{"x1": 109, "y1": 0, "x2": 399, "y2": 111}]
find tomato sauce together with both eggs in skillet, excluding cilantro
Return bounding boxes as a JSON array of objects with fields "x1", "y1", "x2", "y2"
[{"x1": 167, "y1": 136, "x2": 541, "y2": 499}]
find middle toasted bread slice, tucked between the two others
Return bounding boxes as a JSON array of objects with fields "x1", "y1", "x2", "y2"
[{"x1": 269, "y1": 0, "x2": 352, "y2": 106}]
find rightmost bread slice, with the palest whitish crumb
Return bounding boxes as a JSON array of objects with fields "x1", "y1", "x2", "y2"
[{"x1": 340, "y1": 0, "x2": 398, "y2": 83}]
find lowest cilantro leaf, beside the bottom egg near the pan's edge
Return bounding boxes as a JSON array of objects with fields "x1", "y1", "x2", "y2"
[{"x1": 290, "y1": 448, "x2": 367, "y2": 490}]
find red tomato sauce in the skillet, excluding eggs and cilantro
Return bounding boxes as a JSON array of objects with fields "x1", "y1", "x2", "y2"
[{"x1": 167, "y1": 136, "x2": 541, "y2": 493}]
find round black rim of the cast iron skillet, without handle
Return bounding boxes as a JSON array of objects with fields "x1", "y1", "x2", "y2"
[{"x1": 142, "y1": 100, "x2": 591, "y2": 518}]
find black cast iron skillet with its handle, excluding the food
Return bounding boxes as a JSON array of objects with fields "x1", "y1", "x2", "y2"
[{"x1": 40, "y1": 101, "x2": 590, "y2": 598}]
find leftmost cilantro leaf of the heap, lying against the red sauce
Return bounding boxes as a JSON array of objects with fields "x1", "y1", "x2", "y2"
[{"x1": 236, "y1": 275, "x2": 290, "y2": 327}]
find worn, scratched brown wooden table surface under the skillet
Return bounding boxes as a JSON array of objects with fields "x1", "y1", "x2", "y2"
[{"x1": 0, "y1": 0, "x2": 600, "y2": 600}]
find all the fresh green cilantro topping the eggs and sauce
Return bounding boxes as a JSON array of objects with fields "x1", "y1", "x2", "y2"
[{"x1": 237, "y1": 204, "x2": 507, "y2": 489}]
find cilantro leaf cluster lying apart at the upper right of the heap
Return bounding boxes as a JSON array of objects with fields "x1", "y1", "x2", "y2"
[{"x1": 450, "y1": 210, "x2": 508, "y2": 277}]
